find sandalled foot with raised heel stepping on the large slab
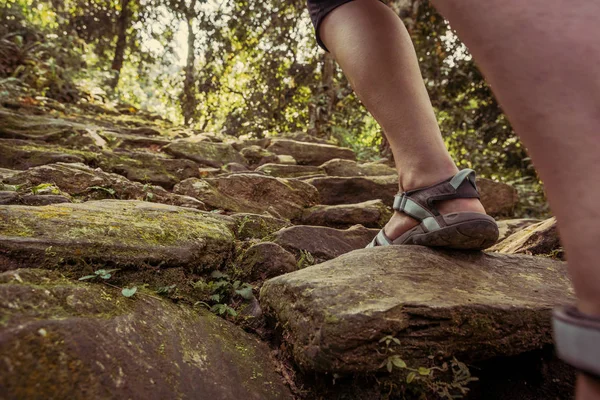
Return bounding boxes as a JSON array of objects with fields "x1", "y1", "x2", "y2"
[{"x1": 367, "y1": 169, "x2": 498, "y2": 249}]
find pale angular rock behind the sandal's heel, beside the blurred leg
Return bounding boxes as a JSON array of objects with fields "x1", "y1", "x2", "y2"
[{"x1": 490, "y1": 217, "x2": 564, "y2": 259}]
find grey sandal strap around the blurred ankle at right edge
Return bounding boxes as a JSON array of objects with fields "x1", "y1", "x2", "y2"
[{"x1": 552, "y1": 307, "x2": 600, "y2": 380}]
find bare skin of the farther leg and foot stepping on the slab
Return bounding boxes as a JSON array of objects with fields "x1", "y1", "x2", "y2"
[{"x1": 319, "y1": 0, "x2": 485, "y2": 238}]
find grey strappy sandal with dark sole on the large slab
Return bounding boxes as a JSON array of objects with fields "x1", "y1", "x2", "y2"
[{"x1": 367, "y1": 169, "x2": 499, "y2": 250}]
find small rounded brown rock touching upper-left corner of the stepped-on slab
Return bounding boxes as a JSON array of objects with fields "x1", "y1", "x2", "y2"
[{"x1": 236, "y1": 242, "x2": 298, "y2": 282}]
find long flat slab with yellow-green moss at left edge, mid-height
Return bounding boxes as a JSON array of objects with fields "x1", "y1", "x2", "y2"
[{"x1": 0, "y1": 200, "x2": 234, "y2": 270}]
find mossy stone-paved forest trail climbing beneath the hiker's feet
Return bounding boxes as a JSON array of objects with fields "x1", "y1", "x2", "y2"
[{"x1": 0, "y1": 104, "x2": 574, "y2": 400}]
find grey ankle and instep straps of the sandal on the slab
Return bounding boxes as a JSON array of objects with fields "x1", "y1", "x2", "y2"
[{"x1": 392, "y1": 169, "x2": 479, "y2": 225}]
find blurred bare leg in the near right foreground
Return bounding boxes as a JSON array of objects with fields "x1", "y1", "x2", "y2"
[{"x1": 422, "y1": 0, "x2": 600, "y2": 399}]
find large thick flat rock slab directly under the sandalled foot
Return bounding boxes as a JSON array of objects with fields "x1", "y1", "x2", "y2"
[{"x1": 260, "y1": 246, "x2": 574, "y2": 372}]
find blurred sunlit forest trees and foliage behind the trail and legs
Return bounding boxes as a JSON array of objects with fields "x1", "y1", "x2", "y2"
[{"x1": 0, "y1": 0, "x2": 548, "y2": 216}]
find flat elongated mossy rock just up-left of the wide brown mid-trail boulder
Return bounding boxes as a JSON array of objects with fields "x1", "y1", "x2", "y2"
[{"x1": 96, "y1": 151, "x2": 200, "y2": 189}]
